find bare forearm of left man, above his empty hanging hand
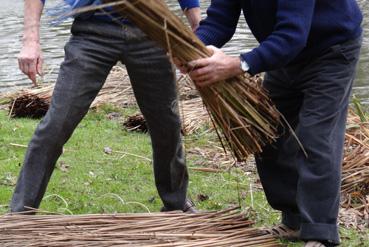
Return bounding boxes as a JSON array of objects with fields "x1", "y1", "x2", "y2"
[{"x1": 23, "y1": 0, "x2": 44, "y2": 43}]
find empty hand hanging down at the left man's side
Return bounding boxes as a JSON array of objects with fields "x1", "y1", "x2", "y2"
[{"x1": 18, "y1": 41, "x2": 43, "y2": 86}]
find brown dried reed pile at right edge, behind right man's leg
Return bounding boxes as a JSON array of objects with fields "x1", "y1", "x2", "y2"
[{"x1": 341, "y1": 110, "x2": 369, "y2": 216}]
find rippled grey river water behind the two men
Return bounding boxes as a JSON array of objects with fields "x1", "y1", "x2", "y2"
[{"x1": 0, "y1": 0, "x2": 369, "y2": 104}]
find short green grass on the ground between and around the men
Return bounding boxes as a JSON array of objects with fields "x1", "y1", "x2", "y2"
[{"x1": 0, "y1": 106, "x2": 369, "y2": 246}]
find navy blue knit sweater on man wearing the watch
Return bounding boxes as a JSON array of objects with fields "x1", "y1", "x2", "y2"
[{"x1": 196, "y1": 0, "x2": 362, "y2": 74}]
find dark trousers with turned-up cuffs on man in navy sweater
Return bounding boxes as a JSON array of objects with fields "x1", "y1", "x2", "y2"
[{"x1": 256, "y1": 35, "x2": 361, "y2": 244}]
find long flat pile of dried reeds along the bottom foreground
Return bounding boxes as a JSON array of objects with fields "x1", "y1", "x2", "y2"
[{"x1": 0, "y1": 209, "x2": 280, "y2": 247}]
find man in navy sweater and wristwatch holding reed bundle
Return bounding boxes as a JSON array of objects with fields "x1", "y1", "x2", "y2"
[{"x1": 181, "y1": 0, "x2": 362, "y2": 246}]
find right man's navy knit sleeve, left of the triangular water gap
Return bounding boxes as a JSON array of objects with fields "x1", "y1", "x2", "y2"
[{"x1": 196, "y1": 0, "x2": 241, "y2": 48}]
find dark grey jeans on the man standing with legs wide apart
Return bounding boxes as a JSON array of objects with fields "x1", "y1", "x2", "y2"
[{"x1": 10, "y1": 20, "x2": 188, "y2": 212}]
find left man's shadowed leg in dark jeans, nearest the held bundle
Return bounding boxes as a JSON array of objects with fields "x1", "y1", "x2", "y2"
[{"x1": 122, "y1": 26, "x2": 188, "y2": 210}]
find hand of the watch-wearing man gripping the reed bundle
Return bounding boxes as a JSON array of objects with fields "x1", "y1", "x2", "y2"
[{"x1": 188, "y1": 46, "x2": 244, "y2": 87}]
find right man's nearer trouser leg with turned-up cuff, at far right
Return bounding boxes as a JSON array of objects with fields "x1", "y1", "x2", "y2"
[{"x1": 296, "y1": 37, "x2": 361, "y2": 245}]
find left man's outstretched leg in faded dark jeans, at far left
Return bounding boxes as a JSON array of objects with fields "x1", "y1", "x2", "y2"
[{"x1": 10, "y1": 19, "x2": 119, "y2": 212}]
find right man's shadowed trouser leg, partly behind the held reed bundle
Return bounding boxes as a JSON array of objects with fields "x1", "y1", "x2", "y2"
[{"x1": 255, "y1": 69, "x2": 302, "y2": 230}]
